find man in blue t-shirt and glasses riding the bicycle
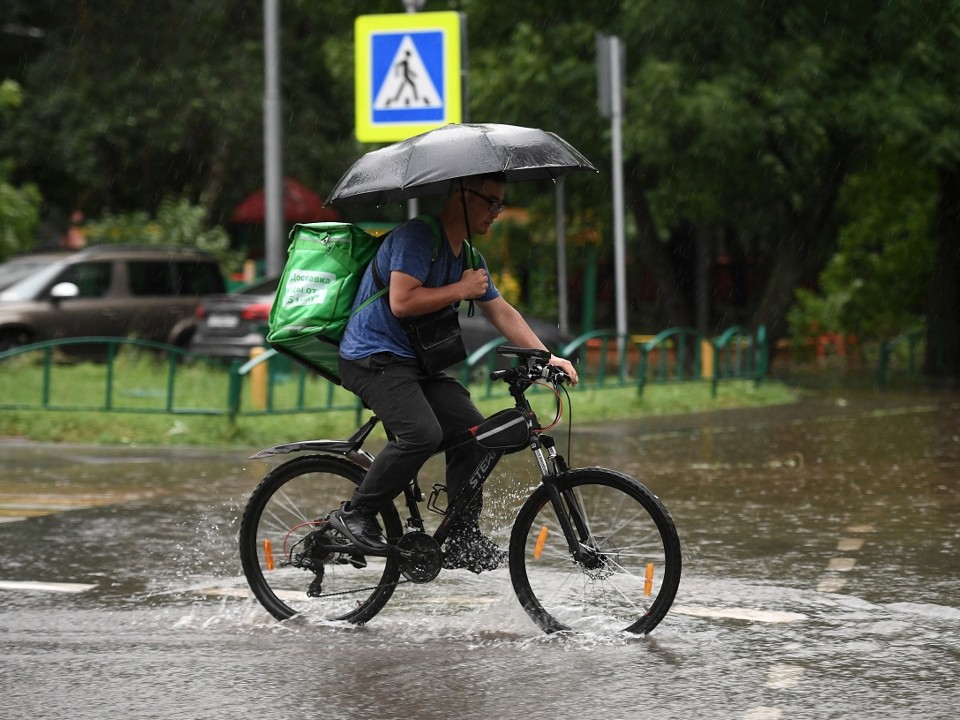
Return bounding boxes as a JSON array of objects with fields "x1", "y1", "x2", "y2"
[{"x1": 330, "y1": 173, "x2": 577, "y2": 573}]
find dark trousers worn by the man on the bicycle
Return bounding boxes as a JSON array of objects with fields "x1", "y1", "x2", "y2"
[{"x1": 340, "y1": 353, "x2": 485, "y2": 515}]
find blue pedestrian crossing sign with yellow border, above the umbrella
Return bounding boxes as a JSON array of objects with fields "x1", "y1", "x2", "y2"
[{"x1": 355, "y1": 12, "x2": 463, "y2": 142}]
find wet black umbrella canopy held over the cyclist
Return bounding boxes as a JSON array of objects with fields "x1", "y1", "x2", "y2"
[{"x1": 327, "y1": 123, "x2": 596, "y2": 205}]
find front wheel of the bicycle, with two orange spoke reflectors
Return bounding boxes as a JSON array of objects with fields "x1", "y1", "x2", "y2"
[{"x1": 510, "y1": 468, "x2": 682, "y2": 634}]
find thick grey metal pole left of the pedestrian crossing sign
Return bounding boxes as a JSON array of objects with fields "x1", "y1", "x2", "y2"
[{"x1": 263, "y1": 0, "x2": 285, "y2": 276}]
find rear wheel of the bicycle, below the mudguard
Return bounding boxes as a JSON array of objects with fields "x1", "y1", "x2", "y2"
[{"x1": 239, "y1": 455, "x2": 403, "y2": 625}]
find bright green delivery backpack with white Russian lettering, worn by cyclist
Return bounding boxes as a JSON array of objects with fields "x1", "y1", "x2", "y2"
[{"x1": 267, "y1": 215, "x2": 440, "y2": 385}]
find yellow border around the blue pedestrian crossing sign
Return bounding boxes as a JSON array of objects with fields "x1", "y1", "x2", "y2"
[{"x1": 354, "y1": 12, "x2": 463, "y2": 143}]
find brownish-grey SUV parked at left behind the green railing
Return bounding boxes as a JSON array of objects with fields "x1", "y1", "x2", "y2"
[{"x1": 0, "y1": 245, "x2": 225, "y2": 351}]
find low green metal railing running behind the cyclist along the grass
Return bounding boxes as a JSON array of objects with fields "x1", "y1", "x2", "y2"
[{"x1": 0, "y1": 328, "x2": 767, "y2": 419}]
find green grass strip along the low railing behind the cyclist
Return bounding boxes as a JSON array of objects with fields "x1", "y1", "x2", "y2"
[{"x1": 0, "y1": 348, "x2": 796, "y2": 448}]
